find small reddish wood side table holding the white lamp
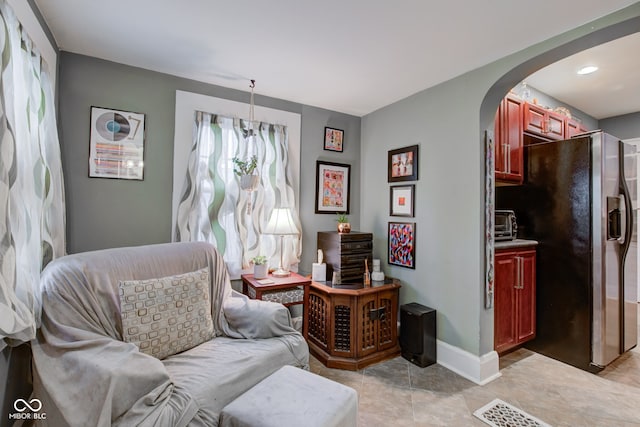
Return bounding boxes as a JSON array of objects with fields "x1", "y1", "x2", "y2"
[{"x1": 240, "y1": 272, "x2": 311, "y2": 339}]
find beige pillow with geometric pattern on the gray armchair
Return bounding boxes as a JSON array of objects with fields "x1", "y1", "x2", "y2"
[{"x1": 119, "y1": 268, "x2": 213, "y2": 359}]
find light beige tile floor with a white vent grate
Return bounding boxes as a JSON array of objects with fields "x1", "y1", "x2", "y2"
[{"x1": 311, "y1": 304, "x2": 640, "y2": 427}]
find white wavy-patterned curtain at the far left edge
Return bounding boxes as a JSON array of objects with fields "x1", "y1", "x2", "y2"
[{"x1": 0, "y1": 0, "x2": 65, "y2": 350}]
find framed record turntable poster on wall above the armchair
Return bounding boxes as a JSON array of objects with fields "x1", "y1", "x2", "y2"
[{"x1": 89, "y1": 106, "x2": 145, "y2": 181}]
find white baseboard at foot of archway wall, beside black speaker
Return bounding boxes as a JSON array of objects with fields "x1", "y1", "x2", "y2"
[{"x1": 436, "y1": 340, "x2": 501, "y2": 385}]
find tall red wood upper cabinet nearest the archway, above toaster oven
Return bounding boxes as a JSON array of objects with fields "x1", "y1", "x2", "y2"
[{"x1": 494, "y1": 95, "x2": 524, "y2": 184}]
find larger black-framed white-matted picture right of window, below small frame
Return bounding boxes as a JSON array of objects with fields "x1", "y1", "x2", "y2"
[{"x1": 315, "y1": 160, "x2": 351, "y2": 214}]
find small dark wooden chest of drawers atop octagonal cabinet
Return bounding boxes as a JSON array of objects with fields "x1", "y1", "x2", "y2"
[{"x1": 318, "y1": 231, "x2": 373, "y2": 283}]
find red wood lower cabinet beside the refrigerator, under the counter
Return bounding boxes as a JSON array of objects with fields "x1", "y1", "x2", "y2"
[{"x1": 493, "y1": 247, "x2": 536, "y2": 354}]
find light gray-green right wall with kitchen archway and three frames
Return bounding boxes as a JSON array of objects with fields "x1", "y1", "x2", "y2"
[{"x1": 361, "y1": 3, "x2": 640, "y2": 357}]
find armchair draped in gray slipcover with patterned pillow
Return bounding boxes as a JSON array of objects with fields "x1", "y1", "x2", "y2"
[{"x1": 32, "y1": 242, "x2": 309, "y2": 426}]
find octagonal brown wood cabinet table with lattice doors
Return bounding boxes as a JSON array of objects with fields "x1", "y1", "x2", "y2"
[{"x1": 307, "y1": 279, "x2": 400, "y2": 371}]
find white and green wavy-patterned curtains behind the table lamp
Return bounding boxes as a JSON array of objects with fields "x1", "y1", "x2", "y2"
[{"x1": 175, "y1": 112, "x2": 302, "y2": 277}]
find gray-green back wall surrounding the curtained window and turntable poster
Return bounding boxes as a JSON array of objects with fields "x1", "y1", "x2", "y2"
[{"x1": 59, "y1": 52, "x2": 360, "y2": 272}]
